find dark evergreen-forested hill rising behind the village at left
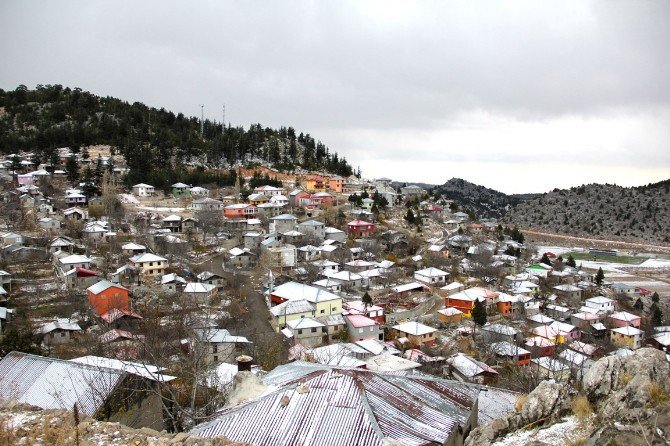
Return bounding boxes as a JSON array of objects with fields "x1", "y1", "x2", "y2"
[{"x1": 0, "y1": 85, "x2": 354, "y2": 184}]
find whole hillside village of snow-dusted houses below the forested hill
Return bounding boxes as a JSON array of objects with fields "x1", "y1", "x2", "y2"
[{"x1": 0, "y1": 146, "x2": 670, "y2": 445}]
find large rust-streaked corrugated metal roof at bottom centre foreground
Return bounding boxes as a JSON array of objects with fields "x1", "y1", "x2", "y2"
[{"x1": 192, "y1": 363, "x2": 478, "y2": 446}]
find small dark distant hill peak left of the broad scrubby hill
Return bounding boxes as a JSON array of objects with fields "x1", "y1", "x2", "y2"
[{"x1": 434, "y1": 178, "x2": 523, "y2": 218}]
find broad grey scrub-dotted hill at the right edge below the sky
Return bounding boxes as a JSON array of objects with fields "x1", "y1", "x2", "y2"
[{"x1": 503, "y1": 180, "x2": 670, "y2": 243}]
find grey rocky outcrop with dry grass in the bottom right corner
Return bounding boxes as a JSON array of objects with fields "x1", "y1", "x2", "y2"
[{"x1": 465, "y1": 348, "x2": 670, "y2": 446}]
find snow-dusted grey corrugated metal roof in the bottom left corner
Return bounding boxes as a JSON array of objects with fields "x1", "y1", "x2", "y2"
[{"x1": 0, "y1": 352, "x2": 125, "y2": 416}]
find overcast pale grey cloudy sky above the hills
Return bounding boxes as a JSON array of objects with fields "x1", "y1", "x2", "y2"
[{"x1": 0, "y1": 0, "x2": 670, "y2": 192}]
